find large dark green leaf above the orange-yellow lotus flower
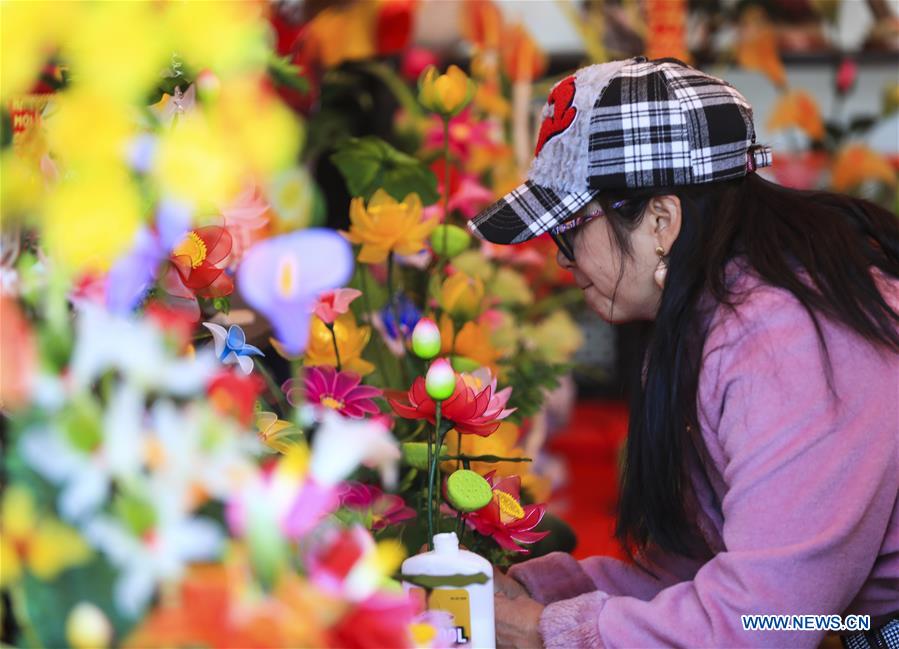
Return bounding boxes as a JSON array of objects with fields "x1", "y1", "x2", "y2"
[{"x1": 331, "y1": 136, "x2": 440, "y2": 205}]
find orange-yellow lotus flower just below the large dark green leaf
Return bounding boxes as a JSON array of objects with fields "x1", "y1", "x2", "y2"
[{"x1": 343, "y1": 189, "x2": 437, "y2": 264}]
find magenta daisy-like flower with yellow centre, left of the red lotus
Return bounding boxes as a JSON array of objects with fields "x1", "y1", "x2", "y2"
[{"x1": 281, "y1": 365, "x2": 382, "y2": 419}]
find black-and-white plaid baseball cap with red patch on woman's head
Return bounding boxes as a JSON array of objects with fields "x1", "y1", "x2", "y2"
[{"x1": 468, "y1": 56, "x2": 772, "y2": 243}]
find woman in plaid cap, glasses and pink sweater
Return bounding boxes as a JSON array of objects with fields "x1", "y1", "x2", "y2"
[{"x1": 471, "y1": 57, "x2": 899, "y2": 648}]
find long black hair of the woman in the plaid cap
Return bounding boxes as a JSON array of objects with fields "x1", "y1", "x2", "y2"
[{"x1": 600, "y1": 173, "x2": 899, "y2": 556}]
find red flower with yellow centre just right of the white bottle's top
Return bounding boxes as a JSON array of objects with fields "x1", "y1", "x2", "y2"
[{"x1": 465, "y1": 471, "x2": 549, "y2": 552}]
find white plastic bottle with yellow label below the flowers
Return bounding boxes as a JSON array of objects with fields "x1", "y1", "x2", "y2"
[{"x1": 402, "y1": 532, "x2": 496, "y2": 649}]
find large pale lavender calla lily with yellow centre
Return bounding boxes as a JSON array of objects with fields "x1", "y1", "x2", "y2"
[{"x1": 237, "y1": 228, "x2": 356, "y2": 354}]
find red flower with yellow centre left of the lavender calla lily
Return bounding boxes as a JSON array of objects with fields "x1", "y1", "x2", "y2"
[{"x1": 170, "y1": 225, "x2": 234, "y2": 297}]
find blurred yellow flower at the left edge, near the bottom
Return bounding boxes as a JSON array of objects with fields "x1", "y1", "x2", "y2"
[{"x1": 0, "y1": 486, "x2": 91, "y2": 587}]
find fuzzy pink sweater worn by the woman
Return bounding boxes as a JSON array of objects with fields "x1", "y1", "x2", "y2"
[{"x1": 509, "y1": 270, "x2": 899, "y2": 649}]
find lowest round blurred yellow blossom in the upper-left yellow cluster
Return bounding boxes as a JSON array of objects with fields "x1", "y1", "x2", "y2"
[{"x1": 43, "y1": 166, "x2": 141, "y2": 271}]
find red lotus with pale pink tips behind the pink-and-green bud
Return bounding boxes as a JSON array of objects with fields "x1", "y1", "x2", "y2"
[{"x1": 387, "y1": 369, "x2": 515, "y2": 437}]
